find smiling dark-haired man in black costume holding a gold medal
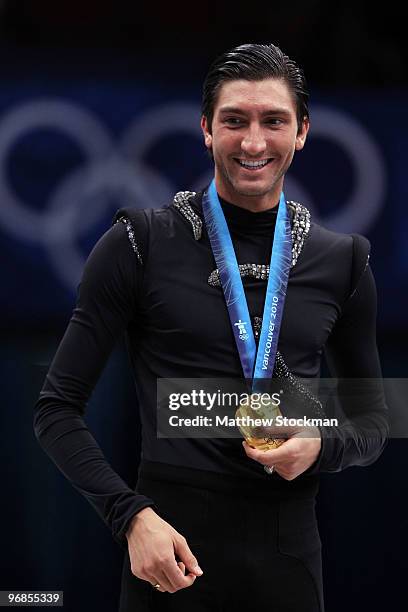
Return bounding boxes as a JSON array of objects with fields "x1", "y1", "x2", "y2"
[{"x1": 35, "y1": 44, "x2": 387, "y2": 612}]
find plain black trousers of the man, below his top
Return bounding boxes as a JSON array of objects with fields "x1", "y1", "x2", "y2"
[{"x1": 119, "y1": 464, "x2": 323, "y2": 612}]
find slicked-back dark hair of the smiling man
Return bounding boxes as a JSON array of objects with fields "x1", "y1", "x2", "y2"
[{"x1": 202, "y1": 44, "x2": 309, "y2": 131}]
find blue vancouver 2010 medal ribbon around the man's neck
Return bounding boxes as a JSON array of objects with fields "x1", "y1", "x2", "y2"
[{"x1": 202, "y1": 179, "x2": 292, "y2": 390}]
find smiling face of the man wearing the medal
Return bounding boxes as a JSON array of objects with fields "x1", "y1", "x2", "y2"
[{"x1": 201, "y1": 79, "x2": 309, "y2": 210}]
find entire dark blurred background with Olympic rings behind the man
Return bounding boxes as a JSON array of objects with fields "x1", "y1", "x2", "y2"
[{"x1": 0, "y1": 0, "x2": 408, "y2": 612}]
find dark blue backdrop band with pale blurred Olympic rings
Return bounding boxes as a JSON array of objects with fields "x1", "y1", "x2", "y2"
[{"x1": 0, "y1": 82, "x2": 408, "y2": 328}]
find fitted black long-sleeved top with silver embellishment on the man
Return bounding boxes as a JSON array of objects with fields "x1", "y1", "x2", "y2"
[{"x1": 34, "y1": 194, "x2": 387, "y2": 549}]
